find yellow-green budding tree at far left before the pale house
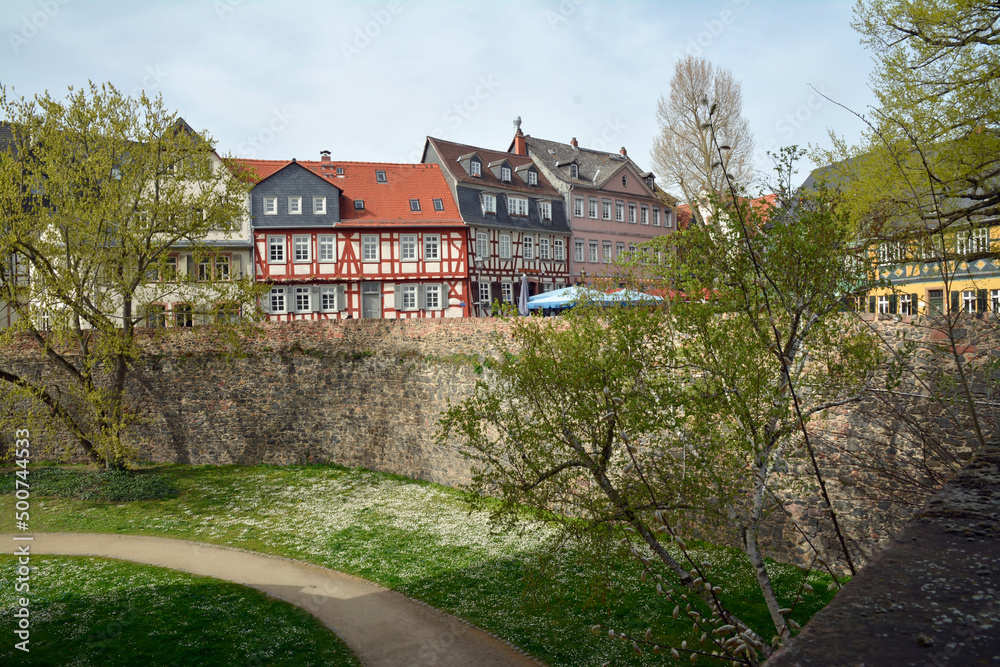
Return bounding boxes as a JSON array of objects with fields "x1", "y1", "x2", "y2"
[{"x1": 0, "y1": 84, "x2": 262, "y2": 467}]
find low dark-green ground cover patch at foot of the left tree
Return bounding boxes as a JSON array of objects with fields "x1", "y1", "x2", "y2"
[{"x1": 0, "y1": 467, "x2": 177, "y2": 502}]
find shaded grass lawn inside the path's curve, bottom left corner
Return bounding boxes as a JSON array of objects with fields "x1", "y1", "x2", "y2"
[{"x1": 0, "y1": 555, "x2": 359, "y2": 667}]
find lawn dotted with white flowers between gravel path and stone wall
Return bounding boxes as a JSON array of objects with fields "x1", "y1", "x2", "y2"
[{"x1": 0, "y1": 465, "x2": 833, "y2": 665}]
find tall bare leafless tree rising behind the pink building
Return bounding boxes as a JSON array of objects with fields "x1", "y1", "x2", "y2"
[{"x1": 652, "y1": 56, "x2": 753, "y2": 223}]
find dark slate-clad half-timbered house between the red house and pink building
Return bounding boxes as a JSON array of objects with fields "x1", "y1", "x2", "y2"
[{"x1": 422, "y1": 137, "x2": 569, "y2": 316}]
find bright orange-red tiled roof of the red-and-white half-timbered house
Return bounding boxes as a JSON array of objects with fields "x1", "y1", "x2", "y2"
[{"x1": 230, "y1": 160, "x2": 465, "y2": 227}]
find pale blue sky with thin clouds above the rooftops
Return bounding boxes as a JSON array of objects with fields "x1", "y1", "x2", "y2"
[{"x1": 0, "y1": 0, "x2": 874, "y2": 194}]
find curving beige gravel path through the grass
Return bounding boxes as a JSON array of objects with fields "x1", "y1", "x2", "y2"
[{"x1": 0, "y1": 533, "x2": 539, "y2": 667}]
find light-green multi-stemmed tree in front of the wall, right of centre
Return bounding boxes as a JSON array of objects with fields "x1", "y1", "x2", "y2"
[{"x1": 441, "y1": 146, "x2": 878, "y2": 661}]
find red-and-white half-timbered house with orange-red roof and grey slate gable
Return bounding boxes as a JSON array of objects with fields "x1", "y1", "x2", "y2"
[{"x1": 244, "y1": 157, "x2": 470, "y2": 321}]
